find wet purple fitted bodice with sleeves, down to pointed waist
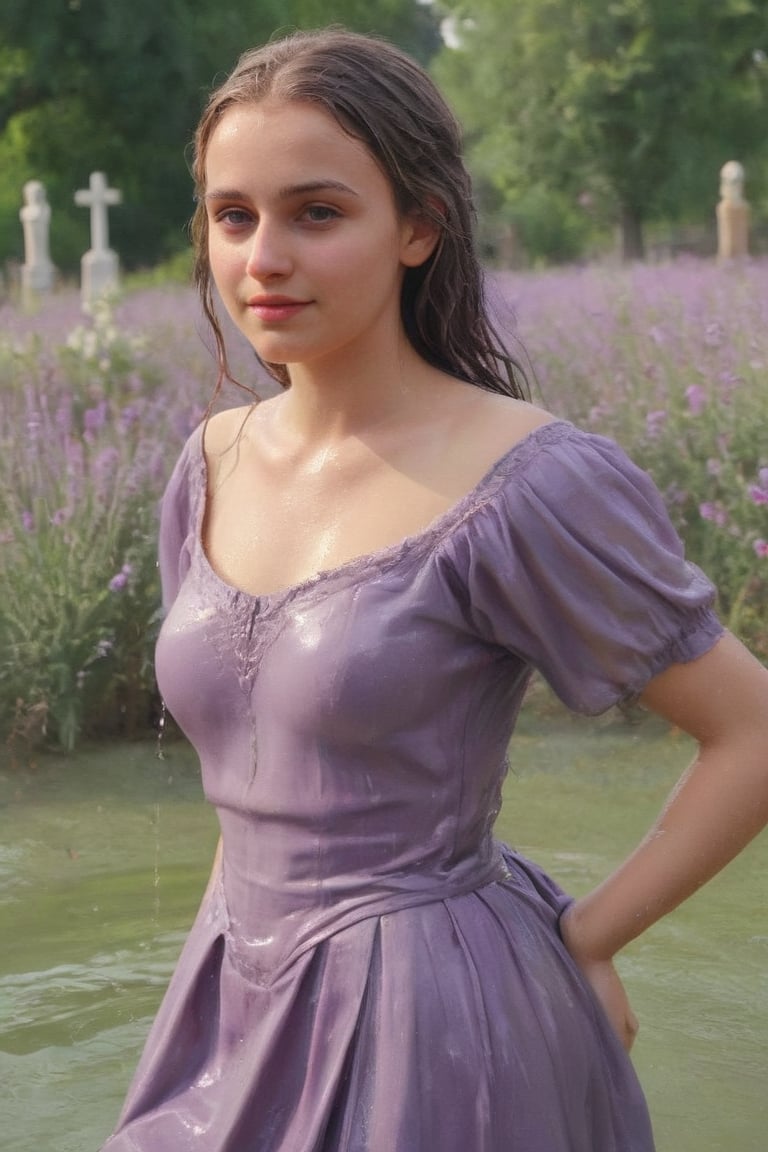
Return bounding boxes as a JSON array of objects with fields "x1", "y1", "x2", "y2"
[{"x1": 157, "y1": 422, "x2": 718, "y2": 978}]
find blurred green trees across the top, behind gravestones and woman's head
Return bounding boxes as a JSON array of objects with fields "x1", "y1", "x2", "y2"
[{"x1": 0, "y1": 0, "x2": 768, "y2": 278}]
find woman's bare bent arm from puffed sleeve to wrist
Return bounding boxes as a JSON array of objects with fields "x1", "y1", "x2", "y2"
[{"x1": 561, "y1": 634, "x2": 768, "y2": 1032}]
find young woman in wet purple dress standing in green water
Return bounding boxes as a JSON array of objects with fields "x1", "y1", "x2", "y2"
[{"x1": 105, "y1": 31, "x2": 768, "y2": 1152}]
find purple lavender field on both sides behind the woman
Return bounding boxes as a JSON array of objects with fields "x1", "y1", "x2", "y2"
[{"x1": 0, "y1": 260, "x2": 768, "y2": 750}]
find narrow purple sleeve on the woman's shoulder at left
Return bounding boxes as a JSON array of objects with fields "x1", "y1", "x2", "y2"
[{"x1": 158, "y1": 427, "x2": 204, "y2": 614}]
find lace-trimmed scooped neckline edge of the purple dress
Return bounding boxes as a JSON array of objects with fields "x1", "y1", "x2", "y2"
[{"x1": 189, "y1": 418, "x2": 579, "y2": 615}]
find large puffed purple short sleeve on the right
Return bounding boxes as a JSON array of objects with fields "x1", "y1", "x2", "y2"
[{"x1": 455, "y1": 422, "x2": 723, "y2": 714}]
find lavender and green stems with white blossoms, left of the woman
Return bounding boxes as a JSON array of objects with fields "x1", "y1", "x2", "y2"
[{"x1": 0, "y1": 293, "x2": 218, "y2": 749}]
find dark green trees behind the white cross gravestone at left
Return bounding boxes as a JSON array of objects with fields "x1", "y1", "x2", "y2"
[{"x1": 0, "y1": 0, "x2": 439, "y2": 271}]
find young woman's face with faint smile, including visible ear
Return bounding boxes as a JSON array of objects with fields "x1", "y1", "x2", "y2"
[{"x1": 205, "y1": 99, "x2": 435, "y2": 367}]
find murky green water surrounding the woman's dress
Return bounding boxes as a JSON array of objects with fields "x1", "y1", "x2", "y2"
[{"x1": 0, "y1": 717, "x2": 768, "y2": 1152}]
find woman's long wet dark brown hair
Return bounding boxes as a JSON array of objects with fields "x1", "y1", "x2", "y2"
[{"x1": 191, "y1": 29, "x2": 527, "y2": 399}]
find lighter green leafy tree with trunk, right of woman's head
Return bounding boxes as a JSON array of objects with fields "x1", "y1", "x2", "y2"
[{"x1": 435, "y1": 0, "x2": 768, "y2": 258}]
